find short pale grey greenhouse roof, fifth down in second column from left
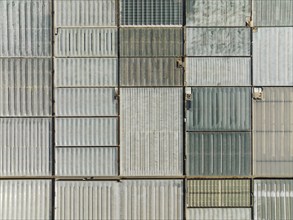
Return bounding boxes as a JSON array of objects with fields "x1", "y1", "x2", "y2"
[{"x1": 55, "y1": 118, "x2": 117, "y2": 146}]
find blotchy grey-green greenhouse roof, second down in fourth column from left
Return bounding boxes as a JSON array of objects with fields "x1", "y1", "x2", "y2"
[{"x1": 186, "y1": 28, "x2": 251, "y2": 56}]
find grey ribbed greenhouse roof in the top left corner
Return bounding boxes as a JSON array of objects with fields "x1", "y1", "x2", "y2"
[{"x1": 0, "y1": 0, "x2": 52, "y2": 57}]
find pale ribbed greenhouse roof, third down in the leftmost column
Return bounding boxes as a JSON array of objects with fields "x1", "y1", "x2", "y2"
[{"x1": 0, "y1": 118, "x2": 52, "y2": 176}]
